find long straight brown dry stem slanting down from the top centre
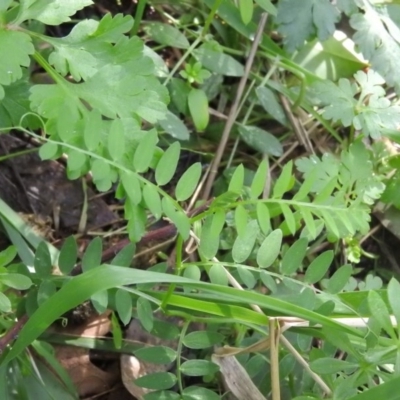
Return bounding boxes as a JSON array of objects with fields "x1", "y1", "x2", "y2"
[{"x1": 203, "y1": 13, "x2": 267, "y2": 199}]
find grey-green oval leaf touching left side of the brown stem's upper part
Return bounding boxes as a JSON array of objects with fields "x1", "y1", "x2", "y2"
[{"x1": 193, "y1": 42, "x2": 244, "y2": 77}]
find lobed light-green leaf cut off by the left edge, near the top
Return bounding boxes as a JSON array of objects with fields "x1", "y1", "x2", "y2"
[{"x1": 0, "y1": 30, "x2": 35, "y2": 100}]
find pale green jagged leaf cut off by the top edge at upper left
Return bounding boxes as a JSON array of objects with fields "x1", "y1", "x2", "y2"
[{"x1": 16, "y1": 0, "x2": 93, "y2": 25}]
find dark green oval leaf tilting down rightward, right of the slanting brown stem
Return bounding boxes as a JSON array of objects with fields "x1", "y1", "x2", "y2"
[{"x1": 239, "y1": 125, "x2": 283, "y2": 157}]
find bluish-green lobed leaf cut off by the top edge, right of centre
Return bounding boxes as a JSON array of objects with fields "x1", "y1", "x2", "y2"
[{"x1": 276, "y1": 0, "x2": 340, "y2": 52}]
